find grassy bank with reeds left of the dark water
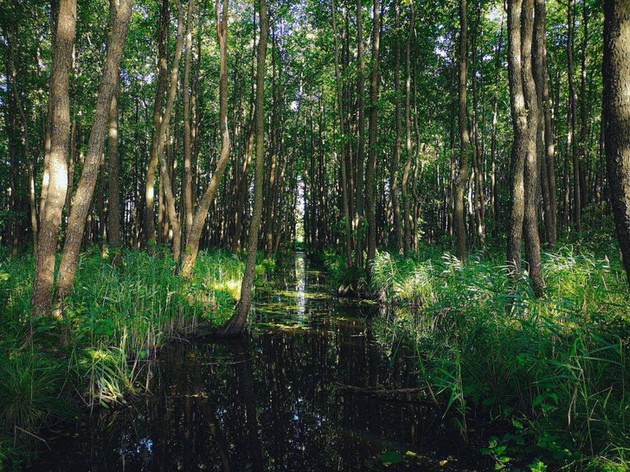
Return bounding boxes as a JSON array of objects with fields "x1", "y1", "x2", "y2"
[{"x1": 0, "y1": 248, "x2": 266, "y2": 470}]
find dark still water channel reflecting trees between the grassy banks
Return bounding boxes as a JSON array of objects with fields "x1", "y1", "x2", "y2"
[{"x1": 31, "y1": 254, "x2": 486, "y2": 472}]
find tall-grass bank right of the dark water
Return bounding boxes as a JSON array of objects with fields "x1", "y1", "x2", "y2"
[{"x1": 327, "y1": 244, "x2": 630, "y2": 471}]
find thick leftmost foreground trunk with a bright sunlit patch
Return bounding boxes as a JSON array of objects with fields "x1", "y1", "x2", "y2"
[{"x1": 31, "y1": 0, "x2": 77, "y2": 315}]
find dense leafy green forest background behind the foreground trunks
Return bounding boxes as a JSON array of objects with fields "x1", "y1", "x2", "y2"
[{"x1": 0, "y1": 0, "x2": 628, "y2": 270}]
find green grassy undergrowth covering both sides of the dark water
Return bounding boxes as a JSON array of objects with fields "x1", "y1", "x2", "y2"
[{"x1": 0, "y1": 242, "x2": 630, "y2": 471}]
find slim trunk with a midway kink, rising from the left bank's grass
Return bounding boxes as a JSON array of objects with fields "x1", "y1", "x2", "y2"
[{"x1": 181, "y1": 0, "x2": 230, "y2": 277}]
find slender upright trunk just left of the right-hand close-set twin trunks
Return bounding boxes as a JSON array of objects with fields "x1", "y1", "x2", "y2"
[{"x1": 454, "y1": 0, "x2": 470, "y2": 262}]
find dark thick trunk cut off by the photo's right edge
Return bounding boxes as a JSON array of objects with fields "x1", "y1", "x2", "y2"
[{"x1": 603, "y1": 0, "x2": 630, "y2": 283}]
